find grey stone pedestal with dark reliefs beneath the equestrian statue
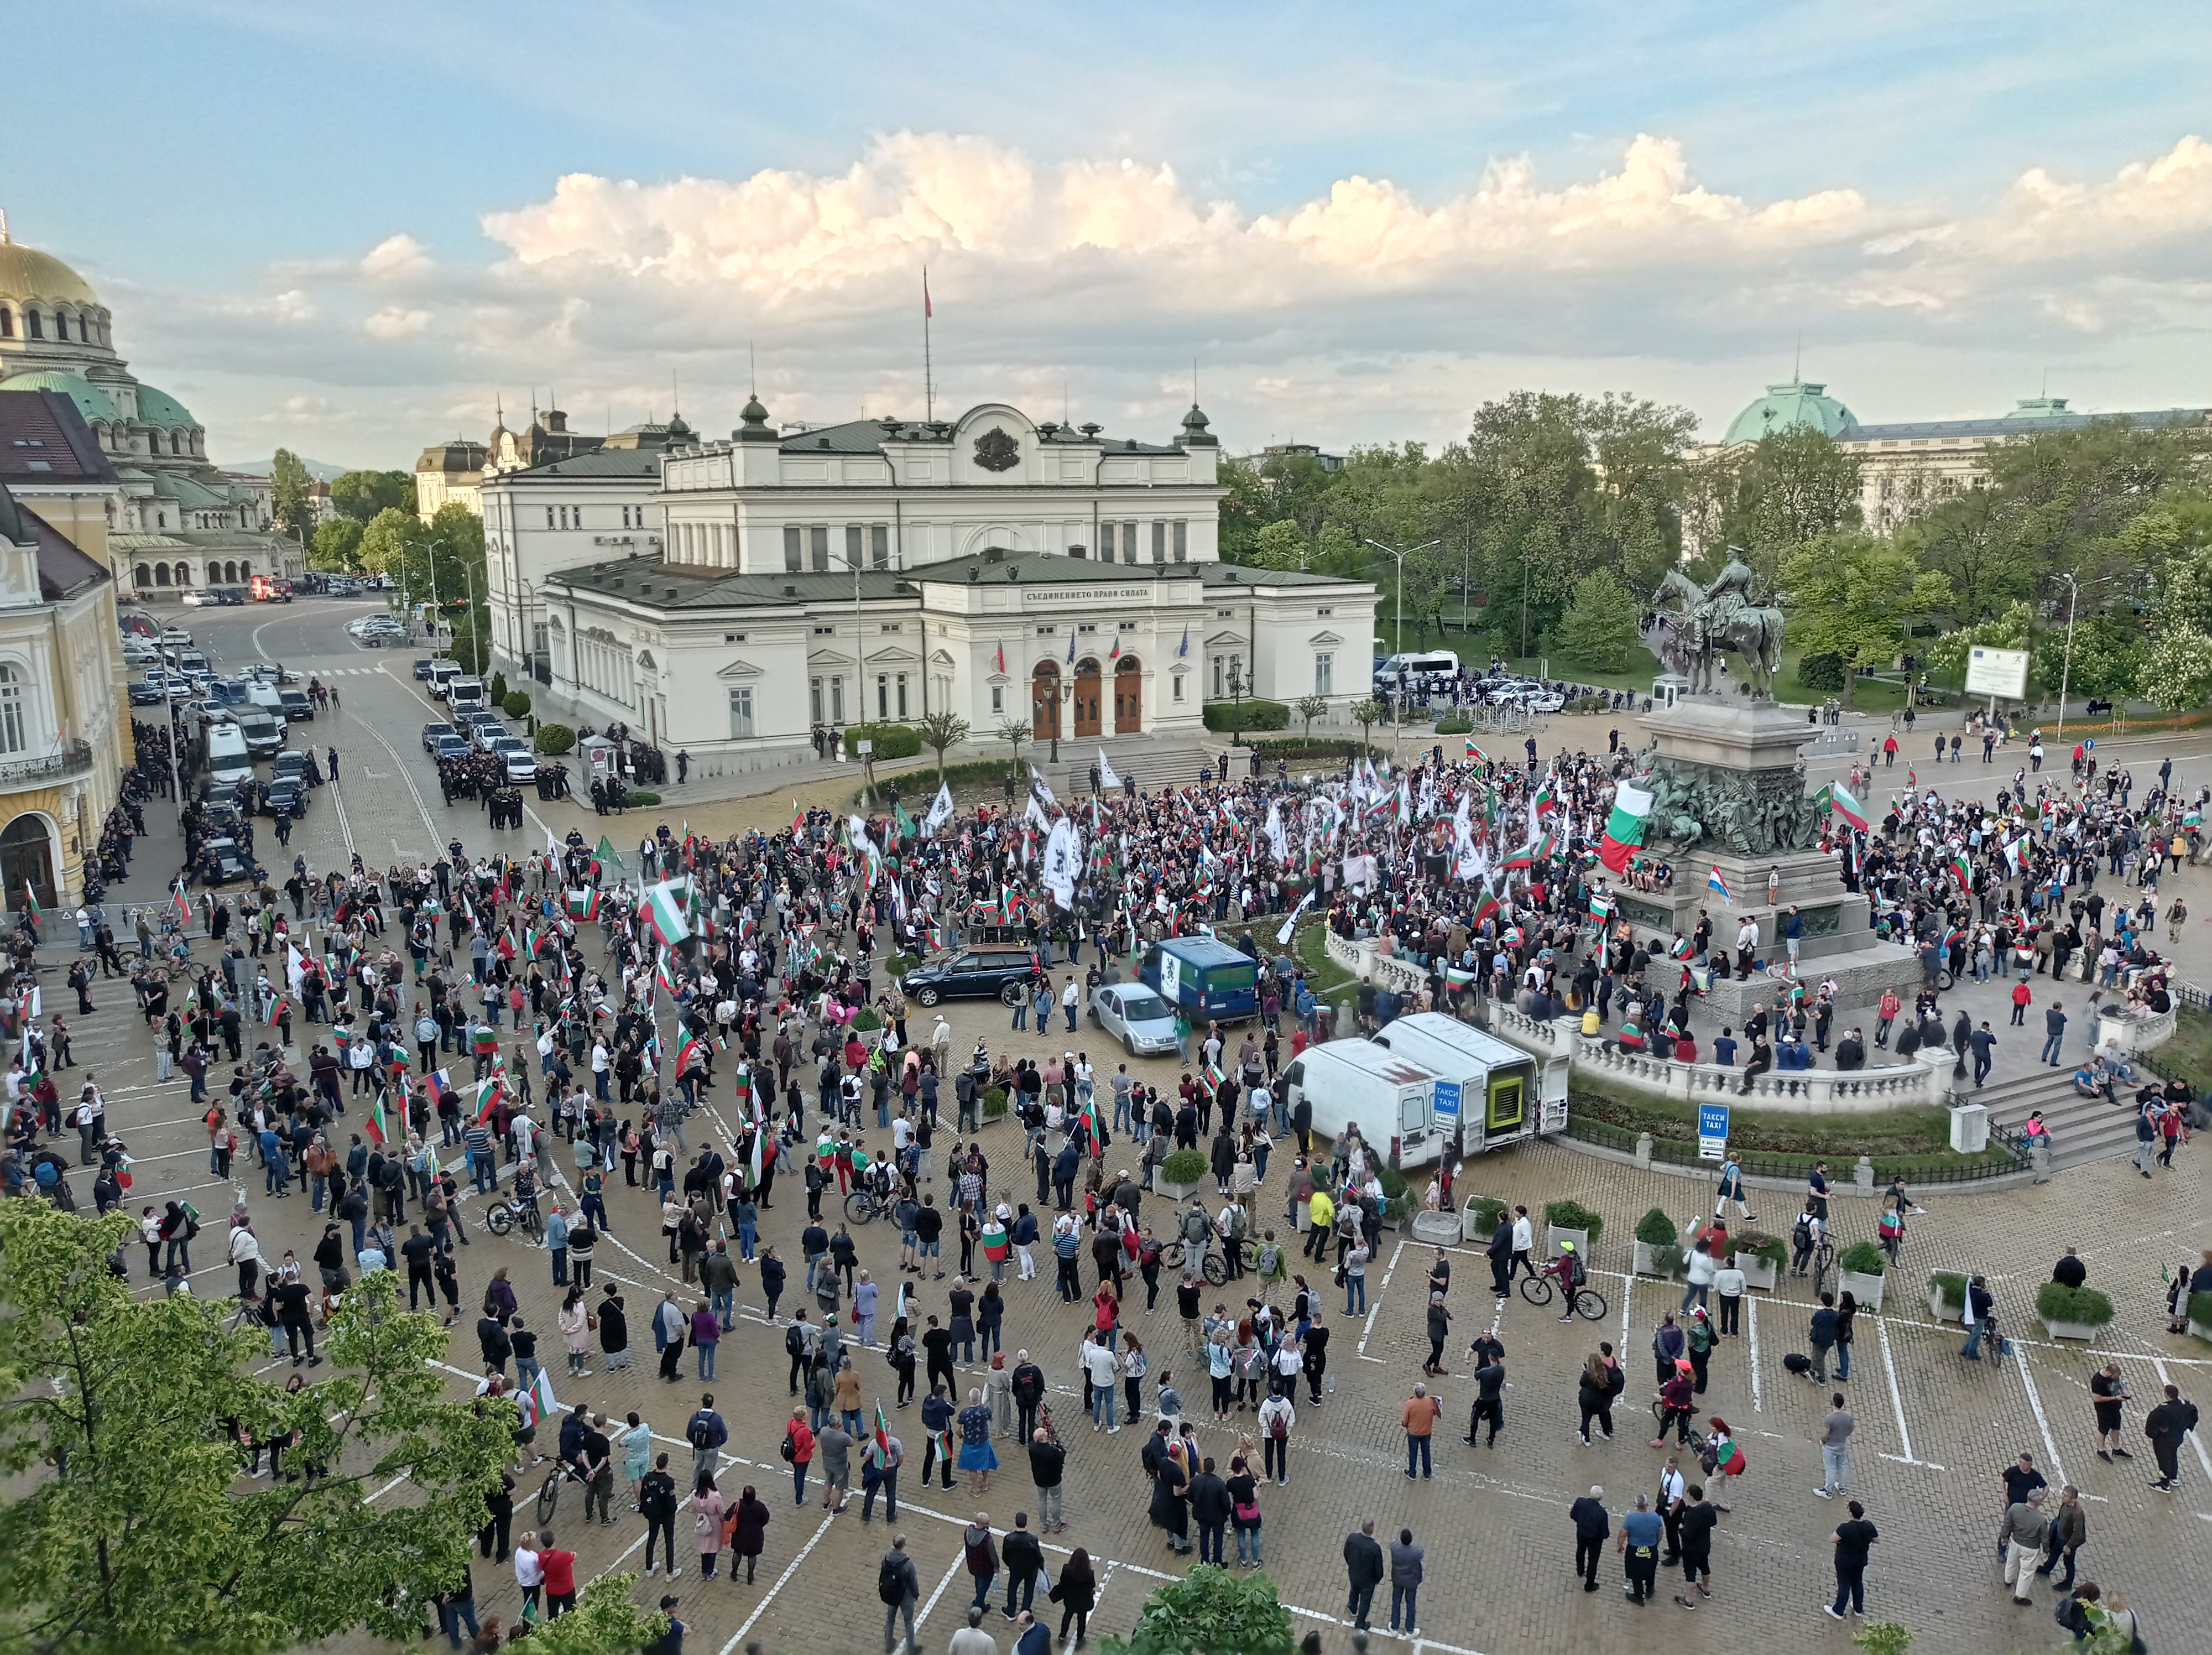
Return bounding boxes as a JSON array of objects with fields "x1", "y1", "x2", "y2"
[{"x1": 1617, "y1": 695, "x2": 1920, "y2": 1027}]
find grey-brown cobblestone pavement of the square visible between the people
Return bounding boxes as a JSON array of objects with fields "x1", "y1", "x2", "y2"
[{"x1": 44, "y1": 604, "x2": 2212, "y2": 1655}]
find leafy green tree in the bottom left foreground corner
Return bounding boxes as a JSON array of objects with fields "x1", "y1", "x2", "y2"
[{"x1": 0, "y1": 1201, "x2": 653, "y2": 1655}]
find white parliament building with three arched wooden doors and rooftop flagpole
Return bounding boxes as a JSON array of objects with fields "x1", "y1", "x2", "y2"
[{"x1": 482, "y1": 400, "x2": 1376, "y2": 774}]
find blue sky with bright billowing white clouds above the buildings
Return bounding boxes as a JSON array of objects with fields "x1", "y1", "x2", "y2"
[{"x1": 0, "y1": 0, "x2": 2212, "y2": 467}]
